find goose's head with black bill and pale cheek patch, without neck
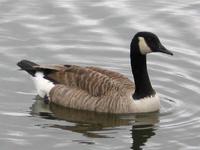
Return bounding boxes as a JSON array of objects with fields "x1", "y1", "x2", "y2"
[{"x1": 132, "y1": 32, "x2": 173, "y2": 55}]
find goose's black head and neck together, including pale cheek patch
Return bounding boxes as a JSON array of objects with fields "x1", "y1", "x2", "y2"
[{"x1": 130, "y1": 32, "x2": 173, "y2": 100}]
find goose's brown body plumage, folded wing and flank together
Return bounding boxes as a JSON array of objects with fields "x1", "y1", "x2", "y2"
[{"x1": 34, "y1": 65, "x2": 134, "y2": 113}]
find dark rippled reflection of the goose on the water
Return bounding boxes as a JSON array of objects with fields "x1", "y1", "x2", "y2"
[{"x1": 31, "y1": 98, "x2": 159, "y2": 150}]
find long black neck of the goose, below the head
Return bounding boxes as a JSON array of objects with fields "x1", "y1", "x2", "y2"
[{"x1": 130, "y1": 43, "x2": 155, "y2": 100}]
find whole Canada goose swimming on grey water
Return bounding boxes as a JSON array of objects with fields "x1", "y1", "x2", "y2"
[{"x1": 17, "y1": 32, "x2": 173, "y2": 113}]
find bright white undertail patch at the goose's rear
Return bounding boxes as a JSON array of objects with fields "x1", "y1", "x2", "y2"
[{"x1": 33, "y1": 72, "x2": 55, "y2": 98}]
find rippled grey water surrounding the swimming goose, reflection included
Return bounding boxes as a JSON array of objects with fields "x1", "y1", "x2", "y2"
[{"x1": 0, "y1": 0, "x2": 200, "y2": 150}]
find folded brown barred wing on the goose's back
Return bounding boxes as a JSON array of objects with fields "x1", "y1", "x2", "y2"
[{"x1": 28, "y1": 65, "x2": 133, "y2": 97}]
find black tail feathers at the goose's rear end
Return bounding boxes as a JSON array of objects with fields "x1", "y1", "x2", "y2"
[{"x1": 17, "y1": 60, "x2": 39, "y2": 76}]
